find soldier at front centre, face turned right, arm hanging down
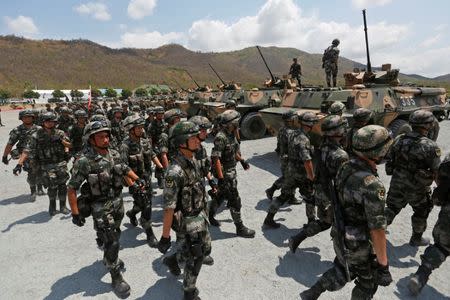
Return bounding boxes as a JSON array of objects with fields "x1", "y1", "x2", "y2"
[{"x1": 158, "y1": 122, "x2": 211, "y2": 300}]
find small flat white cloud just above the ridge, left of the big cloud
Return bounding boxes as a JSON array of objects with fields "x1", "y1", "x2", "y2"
[{"x1": 120, "y1": 31, "x2": 183, "y2": 48}]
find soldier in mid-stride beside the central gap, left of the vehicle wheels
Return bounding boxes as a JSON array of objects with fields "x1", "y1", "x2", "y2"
[{"x1": 209, "y1": 110, "x2": 255, "y2": 238}]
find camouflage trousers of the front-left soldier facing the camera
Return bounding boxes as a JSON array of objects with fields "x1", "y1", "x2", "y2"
[{"x1": 91, "y1": 198, "x2": 124, "y2": 271}]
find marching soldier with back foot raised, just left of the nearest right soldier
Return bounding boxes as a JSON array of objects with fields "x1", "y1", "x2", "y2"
[{"x1": 289, "y1": 115, "x2": 349, "y2": 253}]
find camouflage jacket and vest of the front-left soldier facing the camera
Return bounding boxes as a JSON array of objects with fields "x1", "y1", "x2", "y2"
[{"x1": 67, "y1": 147, "x2": 130, "y2": 202}]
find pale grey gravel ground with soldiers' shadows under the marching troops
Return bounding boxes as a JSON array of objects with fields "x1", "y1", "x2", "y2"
[{"x1": 0, "y1": 111, "x2": 450, "y2": 300}]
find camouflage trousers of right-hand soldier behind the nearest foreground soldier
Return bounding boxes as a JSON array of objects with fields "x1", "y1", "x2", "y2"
[{"x1": 385, "y1": 170, "x2": 433, "y2": 234}]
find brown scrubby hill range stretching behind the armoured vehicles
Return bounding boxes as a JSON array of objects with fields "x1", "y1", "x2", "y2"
[{"x1": 0, "y1": 36, "x2": 450, "y2": 95}]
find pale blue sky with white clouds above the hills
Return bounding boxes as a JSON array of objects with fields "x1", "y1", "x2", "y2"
[{"x1": 0, "y1": 0, "x2": 450, "y2": 77}]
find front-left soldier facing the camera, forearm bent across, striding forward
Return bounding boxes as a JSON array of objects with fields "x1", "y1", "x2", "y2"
[{"x1": 68, "y1": 121, "x2": 144, "y2": 297}]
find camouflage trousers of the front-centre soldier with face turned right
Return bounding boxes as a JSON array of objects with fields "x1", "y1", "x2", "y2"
[{"x1": 182, "y1": 230, "x2": 211, "y2": 292}]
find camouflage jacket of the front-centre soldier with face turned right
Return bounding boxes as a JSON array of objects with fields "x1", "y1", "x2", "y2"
[{"x1": 163, "y1": 153, "x2": 207, "y2": 234}]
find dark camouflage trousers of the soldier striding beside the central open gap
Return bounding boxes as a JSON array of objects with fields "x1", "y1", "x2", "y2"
[{"x1": 209, "y1": 168, "x2": 242, "y2": 224}]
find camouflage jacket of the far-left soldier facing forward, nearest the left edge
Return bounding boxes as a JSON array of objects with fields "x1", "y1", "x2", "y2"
[{"x1": 24, "y1": 127, "x2": 69, "y2": 166}]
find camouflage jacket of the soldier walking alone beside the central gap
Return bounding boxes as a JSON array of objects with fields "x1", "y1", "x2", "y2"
[{"x1": 211, "y1": 130, "x2": 240, "y2": 170}]
